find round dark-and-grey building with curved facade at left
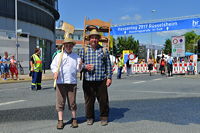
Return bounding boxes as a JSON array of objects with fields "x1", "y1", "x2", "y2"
[{"x1": 0, "y1": 0, "x2": 60, "y2": 73}]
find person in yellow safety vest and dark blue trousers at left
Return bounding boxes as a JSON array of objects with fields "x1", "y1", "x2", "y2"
[{"x1": 30, "y1": 48, "x2": 42, "y2": 90}]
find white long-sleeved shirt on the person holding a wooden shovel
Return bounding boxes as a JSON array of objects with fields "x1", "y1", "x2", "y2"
[{"x1": 51, "y1": 52, "x2": 82, "y2": 84}]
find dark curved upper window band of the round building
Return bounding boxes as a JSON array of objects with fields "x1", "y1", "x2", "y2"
[{"x1": 0, "y1": 0, "x2": 55, "y2": 32}]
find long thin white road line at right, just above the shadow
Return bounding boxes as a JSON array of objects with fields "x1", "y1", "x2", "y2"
[{"x1": 134, "y1": 91, "x2": 200, "y2": 95}]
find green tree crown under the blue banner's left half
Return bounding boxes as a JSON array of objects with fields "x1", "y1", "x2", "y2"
[{"x1": 113, "y1": 36, "x2": 139, "y2": 55}]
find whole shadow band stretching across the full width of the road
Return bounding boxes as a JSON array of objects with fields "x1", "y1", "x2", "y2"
[{"x1": 0, "y1": 97, "x2": 200, "y2": 125}]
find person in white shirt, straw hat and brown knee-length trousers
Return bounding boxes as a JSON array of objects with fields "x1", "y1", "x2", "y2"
[{"x1": 51, "y1": 38, "x2": 82, "y2": 129}]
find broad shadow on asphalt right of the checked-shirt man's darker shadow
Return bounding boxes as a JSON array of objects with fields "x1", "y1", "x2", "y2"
[{"x1": 112, "y1": 97, "x2": 200, "y2": 125}]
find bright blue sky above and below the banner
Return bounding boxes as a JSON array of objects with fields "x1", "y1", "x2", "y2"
[{"x1": 59, "y1": 0, "x2": 200, "y2": 45}]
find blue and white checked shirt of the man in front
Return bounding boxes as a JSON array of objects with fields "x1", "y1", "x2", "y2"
[{"x1": 80, "y1": 45, "x2": 112, "y2": 81}]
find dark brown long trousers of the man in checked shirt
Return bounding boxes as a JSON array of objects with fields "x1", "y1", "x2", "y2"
[{"x1": 83, "y1": 79, "x2": 109, "y2": 120}]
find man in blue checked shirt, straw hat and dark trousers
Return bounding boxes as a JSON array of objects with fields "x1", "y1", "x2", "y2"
[{"x1": 80, "y1": 29, "x2": 112, "y2": 126}]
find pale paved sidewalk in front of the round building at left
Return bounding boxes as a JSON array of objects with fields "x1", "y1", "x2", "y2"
[{"x1": 0, "y1": 70, "x2": 53, "y2": 84}]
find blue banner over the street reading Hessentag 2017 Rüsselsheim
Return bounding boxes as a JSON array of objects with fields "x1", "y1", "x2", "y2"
[{"x1": 111, "y1": 18, "x2": 200, "y2": 35}]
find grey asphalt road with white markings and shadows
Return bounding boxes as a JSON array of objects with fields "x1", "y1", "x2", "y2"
[{"x1": 0, "y1": 74, "x2": 200, "y2": 133}]
